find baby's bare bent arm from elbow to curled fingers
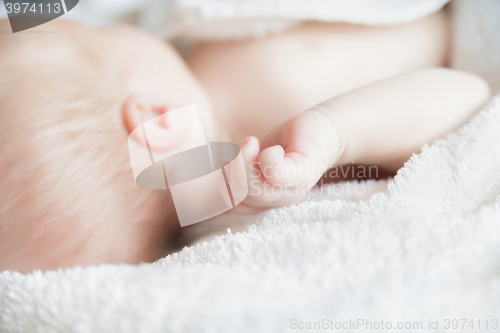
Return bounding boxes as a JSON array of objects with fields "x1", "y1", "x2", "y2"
[{"x1": 240, "y1": 69, "x2": 490, "y2": 211}]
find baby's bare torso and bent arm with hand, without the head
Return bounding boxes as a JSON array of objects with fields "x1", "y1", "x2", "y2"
[{"x1": 188, "y1": 12, "x2": 489, "y2": 214}]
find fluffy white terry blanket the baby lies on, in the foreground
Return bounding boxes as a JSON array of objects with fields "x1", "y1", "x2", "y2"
[{"x1": 0, "y1": 0, "x2": 500, "y2": 333}]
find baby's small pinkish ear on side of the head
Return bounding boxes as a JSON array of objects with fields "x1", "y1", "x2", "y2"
[{"x1": 122, "y1": 95, "x2": 185, "y2": 151}]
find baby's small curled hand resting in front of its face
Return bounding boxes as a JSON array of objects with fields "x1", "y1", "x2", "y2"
[{"x1": 237, "y1": 107, "x2": 342, "y2": 213}]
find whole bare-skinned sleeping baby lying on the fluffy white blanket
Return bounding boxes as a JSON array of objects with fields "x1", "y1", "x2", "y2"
[{"x1": 0, "y1": 8, "x2": 489, "y2": 272}]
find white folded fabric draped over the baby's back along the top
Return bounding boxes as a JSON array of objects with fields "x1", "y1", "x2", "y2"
[{"x1": 142, "y1": 0, "x2": 449, "y2": 42}]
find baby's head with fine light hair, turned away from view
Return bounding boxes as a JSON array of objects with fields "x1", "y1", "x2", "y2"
[{"x1": 0, "y1": 21, "x2": 211, "y2": 272}]
